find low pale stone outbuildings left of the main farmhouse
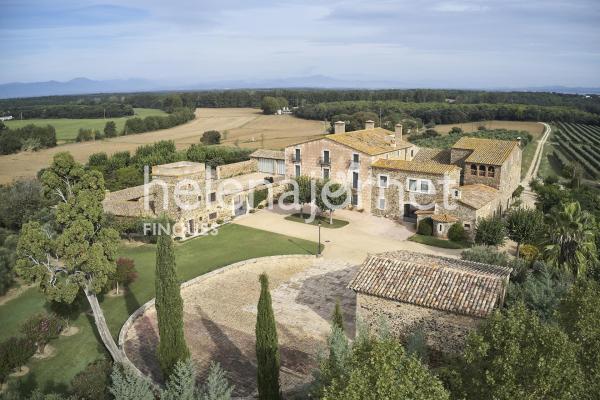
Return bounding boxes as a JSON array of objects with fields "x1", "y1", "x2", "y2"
[{"x1": 102, "y1": 158, "x2": 283, "y2": 238}]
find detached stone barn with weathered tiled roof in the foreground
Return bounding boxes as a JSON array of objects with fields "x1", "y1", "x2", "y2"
[{"x1": 348, "y1": 251, "x2": 511, "y2": 354}]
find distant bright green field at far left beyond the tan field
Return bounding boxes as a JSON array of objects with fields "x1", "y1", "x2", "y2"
[{"x1": 4, "y1": 108, "x2": 166, "y2": 142}]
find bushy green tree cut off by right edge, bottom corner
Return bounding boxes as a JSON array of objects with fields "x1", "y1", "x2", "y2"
[{"x1": 558, "y1": 279, "x2": 600, "y2": 400}]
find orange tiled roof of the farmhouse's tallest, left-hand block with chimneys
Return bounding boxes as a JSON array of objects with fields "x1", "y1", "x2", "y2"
[{"x1": 325, "y1": 128, "x2": 413, "y2": 156}]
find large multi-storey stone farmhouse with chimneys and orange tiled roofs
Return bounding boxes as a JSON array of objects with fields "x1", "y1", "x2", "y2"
[{"x1": 285, "y1": 121, "x2": 521, "y2": 237}]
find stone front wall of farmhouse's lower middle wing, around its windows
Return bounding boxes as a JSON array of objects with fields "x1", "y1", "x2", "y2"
[{"x1": 371, "y1": 167, "x2": 460, "y2": 220}]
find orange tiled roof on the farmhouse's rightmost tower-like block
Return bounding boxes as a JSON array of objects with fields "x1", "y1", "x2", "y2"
[{"x1": 452, "y1": 136, "x2": 519, "y2": 165}]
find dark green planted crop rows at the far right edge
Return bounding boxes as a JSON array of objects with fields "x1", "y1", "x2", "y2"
[{"x1": 554, "y1": 122, "x2": 600, "y2": 179}]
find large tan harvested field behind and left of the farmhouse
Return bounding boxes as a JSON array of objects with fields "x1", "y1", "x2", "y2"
[{"x1": 0, "y1": 108, "x2": 325, "y2": 184}]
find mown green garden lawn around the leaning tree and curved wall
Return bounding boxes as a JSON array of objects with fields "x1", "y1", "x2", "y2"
[{"x1": 0, "y1": 224, "x2": 317, "y2": 392}]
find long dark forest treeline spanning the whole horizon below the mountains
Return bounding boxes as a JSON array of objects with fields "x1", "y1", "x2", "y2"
[{"x1": 0, "y1": 89, "x2": 600, "y2": 117}]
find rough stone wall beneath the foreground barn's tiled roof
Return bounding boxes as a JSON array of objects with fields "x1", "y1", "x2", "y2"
[{"x1": 356, "y1": 293, "x2": 483, "y2": 353}]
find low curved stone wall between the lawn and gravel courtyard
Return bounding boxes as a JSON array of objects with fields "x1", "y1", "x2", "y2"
[{"x1": 118, "y1": 254, "x2": 315, "y2": 386}]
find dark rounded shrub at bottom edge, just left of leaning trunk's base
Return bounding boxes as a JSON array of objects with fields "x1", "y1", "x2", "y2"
[{"x1": 71, "y1": 360, "x2": 112, "y2": 400}]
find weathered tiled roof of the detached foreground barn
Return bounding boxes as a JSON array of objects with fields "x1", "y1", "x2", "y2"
[{"x1": 348, "y1": 251, "x2": 511, "y2": 318}]
